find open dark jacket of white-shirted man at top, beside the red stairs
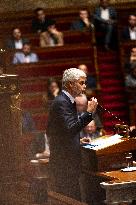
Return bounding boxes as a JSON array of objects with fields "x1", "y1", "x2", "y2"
[{"x1": 93, "y1": 7, "x2": 117, "y2": 23}]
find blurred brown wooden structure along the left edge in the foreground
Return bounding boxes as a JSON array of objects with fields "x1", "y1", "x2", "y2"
[{"x1": 0, "y1": 74, "x2": 30, "y2": 205}]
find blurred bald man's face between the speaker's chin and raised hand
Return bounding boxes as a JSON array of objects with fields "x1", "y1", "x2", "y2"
[{"x1": 75, "y1": 96, "x2": 87, "y2": 113}]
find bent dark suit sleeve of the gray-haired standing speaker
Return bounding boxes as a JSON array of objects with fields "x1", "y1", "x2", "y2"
[{"x1": 54, "y1": 102, "x2": 92, "y2": 136}]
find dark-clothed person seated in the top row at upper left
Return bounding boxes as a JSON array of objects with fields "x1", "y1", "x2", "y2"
[{"x1": 32, "y1": 8, "x2": 53, "y2": 33}]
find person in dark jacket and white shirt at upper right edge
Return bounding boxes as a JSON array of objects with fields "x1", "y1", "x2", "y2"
[{"x1": 122, "y1": 14, "x2": 136, "y2": 40}]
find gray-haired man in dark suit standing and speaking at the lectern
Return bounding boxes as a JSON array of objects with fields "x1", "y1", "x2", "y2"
[{"x1": 47, "y1": 68, "x2": 97, "y2": 200}]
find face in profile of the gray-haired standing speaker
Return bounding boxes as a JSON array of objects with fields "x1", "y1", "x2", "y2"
[{"x1": 70, "y1": 77, "x2": 86, "y2": 97}]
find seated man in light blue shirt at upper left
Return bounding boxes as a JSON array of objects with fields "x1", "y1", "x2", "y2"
[{"x1": 13, "y1": 43, "x2": 38, "y2": 64}]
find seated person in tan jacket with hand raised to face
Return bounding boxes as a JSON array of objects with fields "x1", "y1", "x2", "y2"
[{"x1": 40, "y1": 20, "x2": 64, "y2": 48}]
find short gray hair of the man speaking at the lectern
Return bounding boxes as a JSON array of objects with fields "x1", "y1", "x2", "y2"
[{"x1": 62, "y1": 68, "x2": 86, "y2": 87}]
